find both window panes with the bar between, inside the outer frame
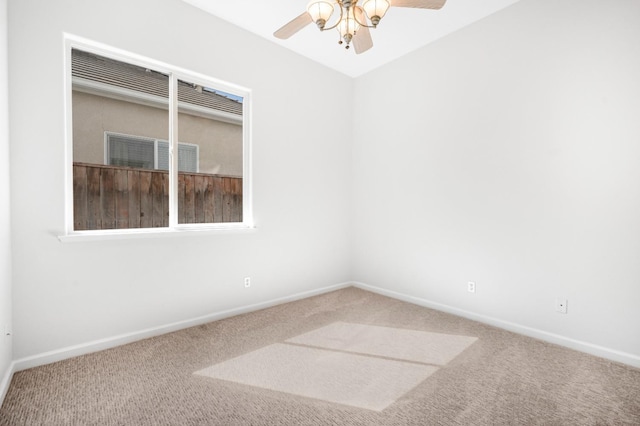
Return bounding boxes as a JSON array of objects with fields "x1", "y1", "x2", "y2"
[{"x1": 70, "y1": 48, "x2": 248, "y2": 231}]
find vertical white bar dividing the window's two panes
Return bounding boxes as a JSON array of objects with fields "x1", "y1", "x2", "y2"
[{"x1": 169, "y1": 73, "x2": 178, "y2": 228}]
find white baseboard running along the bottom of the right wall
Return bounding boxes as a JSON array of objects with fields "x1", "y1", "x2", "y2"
[{"x1": 353, "y1": 282, "x2": 640, "y2": 368}]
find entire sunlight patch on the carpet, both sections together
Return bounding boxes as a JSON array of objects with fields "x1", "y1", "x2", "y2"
[{"x1": 194, "y1": 322, "x2": 477, "y2": 411}]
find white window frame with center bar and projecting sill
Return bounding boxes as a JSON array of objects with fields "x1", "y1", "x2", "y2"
[{"x1": 58, "y1": 34, "x2": 255, "y2": 242}]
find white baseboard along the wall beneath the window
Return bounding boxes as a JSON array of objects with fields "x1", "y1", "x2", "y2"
[{"x1": 11, "y1": 282, "x2": 352, "y2": 372}]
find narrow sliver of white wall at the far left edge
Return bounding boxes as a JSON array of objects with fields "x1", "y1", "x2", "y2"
[{"x1": 0, "y1": 0, "x2": 13, "y2": 392}]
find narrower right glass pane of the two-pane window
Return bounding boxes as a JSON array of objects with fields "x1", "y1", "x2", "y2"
[{"x1": 178, "y1": 80, "x2": 243, "y2": 223}]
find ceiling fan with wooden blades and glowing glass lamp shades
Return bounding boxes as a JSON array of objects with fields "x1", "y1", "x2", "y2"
[{"x1": 273, "y1": 0, "x2": 447, "y2": 54}]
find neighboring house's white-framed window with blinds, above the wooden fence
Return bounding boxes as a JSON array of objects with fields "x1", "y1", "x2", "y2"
[{"x1": 105, "y1": 132, "x2": 198, "y2": 172}]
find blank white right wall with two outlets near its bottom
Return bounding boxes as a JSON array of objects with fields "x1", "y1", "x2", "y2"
[{"x1": 352, "y1": 0, "x2": 640, "y2": 365}]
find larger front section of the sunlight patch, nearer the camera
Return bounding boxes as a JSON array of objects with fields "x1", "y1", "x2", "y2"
[{"x1": 196, "y1": 343, "x2": 437, "y2": 411}]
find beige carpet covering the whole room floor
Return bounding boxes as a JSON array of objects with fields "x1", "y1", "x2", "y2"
[{"x1": 0, "y1": 288, "x2": 640, "y2": 425}]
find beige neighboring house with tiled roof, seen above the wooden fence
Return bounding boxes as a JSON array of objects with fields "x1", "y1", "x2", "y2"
[{"x1": 72, "y1": 49, "x2": 243, "y2": 177}]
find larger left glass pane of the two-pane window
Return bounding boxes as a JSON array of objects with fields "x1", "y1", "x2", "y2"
[{"x1": 71, "y1": 49, "x2": 169, "y2": 230}]
